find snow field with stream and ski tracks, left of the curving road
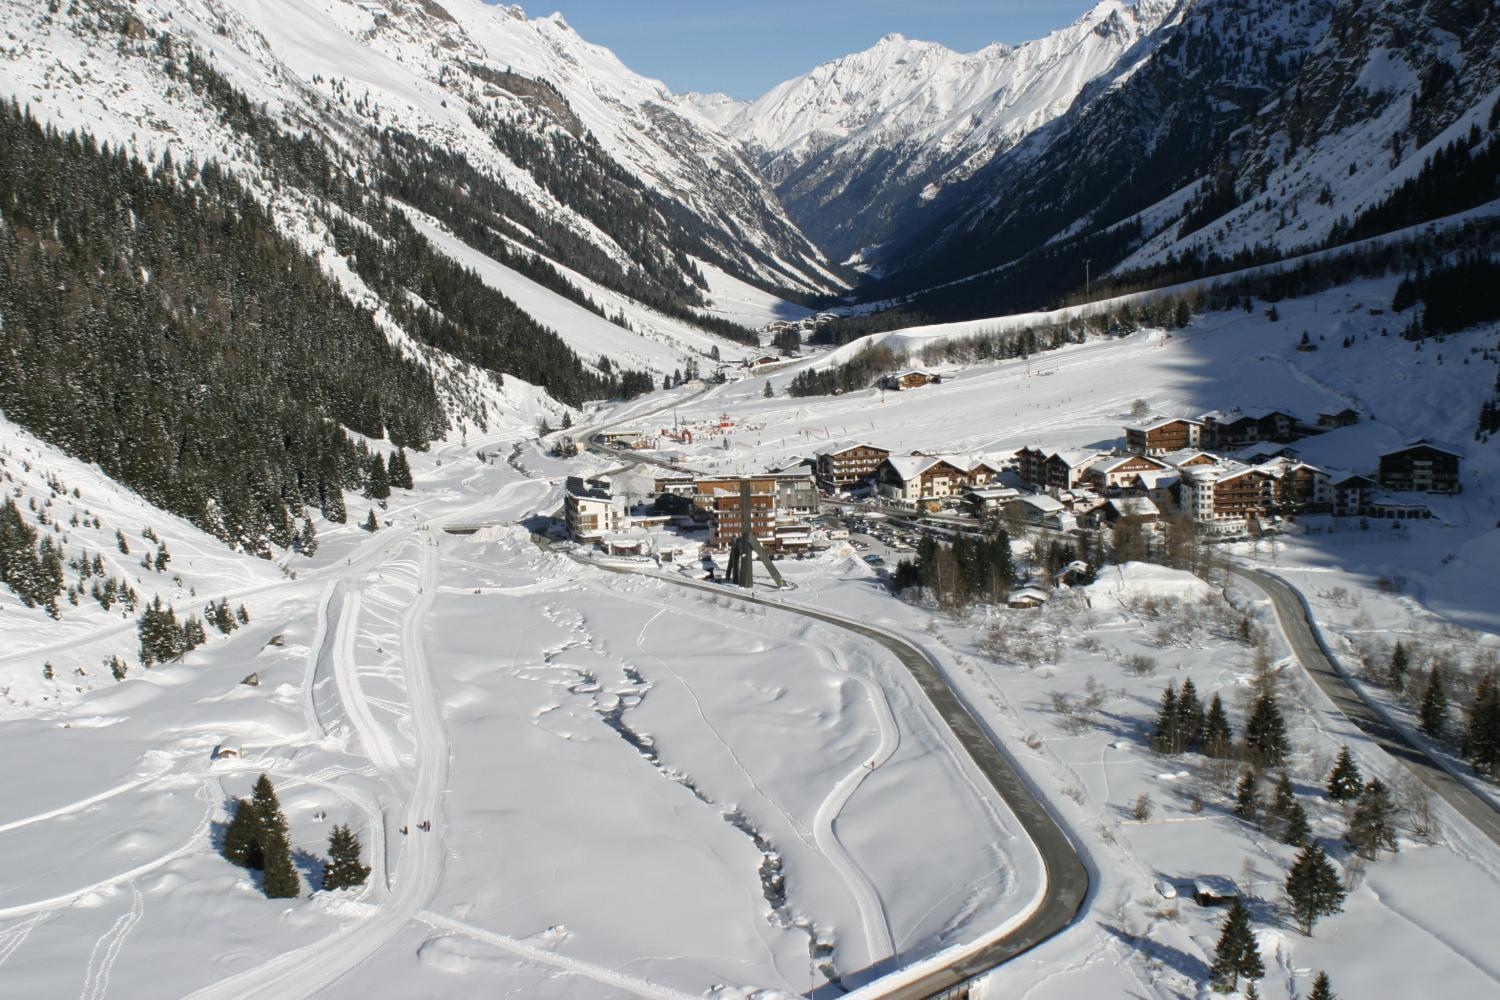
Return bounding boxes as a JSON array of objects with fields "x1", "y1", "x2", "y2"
[{"x1": 0, "y1": 410, "x2": 1040, "y2": 997}]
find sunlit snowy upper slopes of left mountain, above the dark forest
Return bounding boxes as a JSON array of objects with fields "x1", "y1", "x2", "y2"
[{"x1": 0, "y1": 0, "x2": 842, "y2": 370}]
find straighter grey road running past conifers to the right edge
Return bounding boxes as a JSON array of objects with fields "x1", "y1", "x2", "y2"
[{"x1": 1226, "y1": 567, "x2": 1500, "y2": 844}]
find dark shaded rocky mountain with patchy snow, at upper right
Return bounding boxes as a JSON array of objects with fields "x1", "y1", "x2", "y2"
[{"x1": 852, "y1": 0, "x2": 1500, "y2": 315}]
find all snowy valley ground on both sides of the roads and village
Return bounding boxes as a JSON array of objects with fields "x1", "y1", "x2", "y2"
[{"x1": 0, "y1": 269, "x2": 1500, "y2": 1000}]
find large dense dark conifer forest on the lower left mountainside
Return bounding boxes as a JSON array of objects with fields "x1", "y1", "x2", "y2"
[{"x1": 0, "y1": 100, "x2": 444, "y2": 555}]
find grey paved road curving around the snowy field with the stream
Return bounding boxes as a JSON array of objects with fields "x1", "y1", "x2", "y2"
[{"x1": 588, "y1": 560, "x2": 1089, "y2": 1000}]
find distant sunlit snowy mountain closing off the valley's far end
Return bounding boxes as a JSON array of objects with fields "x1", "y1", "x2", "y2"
[{"x1": 708, "y1": 0, "x2": 1175, "y2": 263}]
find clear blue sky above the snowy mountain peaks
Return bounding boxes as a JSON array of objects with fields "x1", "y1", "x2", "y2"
[{"x1": 498, "y1": 0, "x2": 1092, "y2": 97}]
